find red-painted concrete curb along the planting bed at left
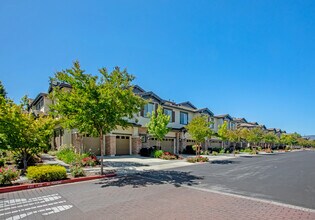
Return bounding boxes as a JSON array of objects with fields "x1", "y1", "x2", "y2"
[{"x1": 0, "y1": 173, "x2": 116, "y2": 194}]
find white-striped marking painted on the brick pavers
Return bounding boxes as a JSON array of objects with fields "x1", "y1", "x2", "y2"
[{"x1": 0, "y1": 193, "x2": 73, "y2": 220}]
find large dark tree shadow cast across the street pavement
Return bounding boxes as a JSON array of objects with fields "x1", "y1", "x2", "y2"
[{"x1": 96, "y1": 170, "x2": 203, "y2": 188}]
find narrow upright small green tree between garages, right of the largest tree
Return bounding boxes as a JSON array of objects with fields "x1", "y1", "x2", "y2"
[{"x1": 147, "y1": 106, "x2": 170, "y2": 148}]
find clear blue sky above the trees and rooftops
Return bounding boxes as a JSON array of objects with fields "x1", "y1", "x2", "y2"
[{"x1": 0, "y1": 0, "x2": 315, "y2": 135}]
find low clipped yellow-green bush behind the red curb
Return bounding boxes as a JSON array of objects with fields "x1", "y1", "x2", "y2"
[{"x1": 26, "y1": 165, "x2": 67, "y2": 182}]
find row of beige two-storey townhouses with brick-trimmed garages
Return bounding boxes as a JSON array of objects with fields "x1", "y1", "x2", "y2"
[{"x1": 29, "y1": 83, "x2": 285, "y2": 156}]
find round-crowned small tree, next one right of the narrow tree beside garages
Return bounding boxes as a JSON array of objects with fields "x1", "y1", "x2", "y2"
[{"x1": 186, "y1": 116, "x2": 213, "y2": 155}]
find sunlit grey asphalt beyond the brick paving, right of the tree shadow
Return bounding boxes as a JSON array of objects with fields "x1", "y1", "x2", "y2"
[{"x1": 176, "y1": 151, "x2": 315, "y2": 209}]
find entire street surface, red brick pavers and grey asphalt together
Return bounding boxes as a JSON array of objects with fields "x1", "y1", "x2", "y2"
[{"x1": 0, "y1": 152, "x2": 315, "y2": 219}]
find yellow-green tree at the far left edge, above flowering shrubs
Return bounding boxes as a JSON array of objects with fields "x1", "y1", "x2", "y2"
[{"x1": 0, "y1": 97, "x2": 54, "y2": 171}]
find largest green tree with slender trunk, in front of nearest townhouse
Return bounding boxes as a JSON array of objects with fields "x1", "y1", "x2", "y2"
[{"x1": 50, "y1": 61, "x2": 145, "y2": 174}]
